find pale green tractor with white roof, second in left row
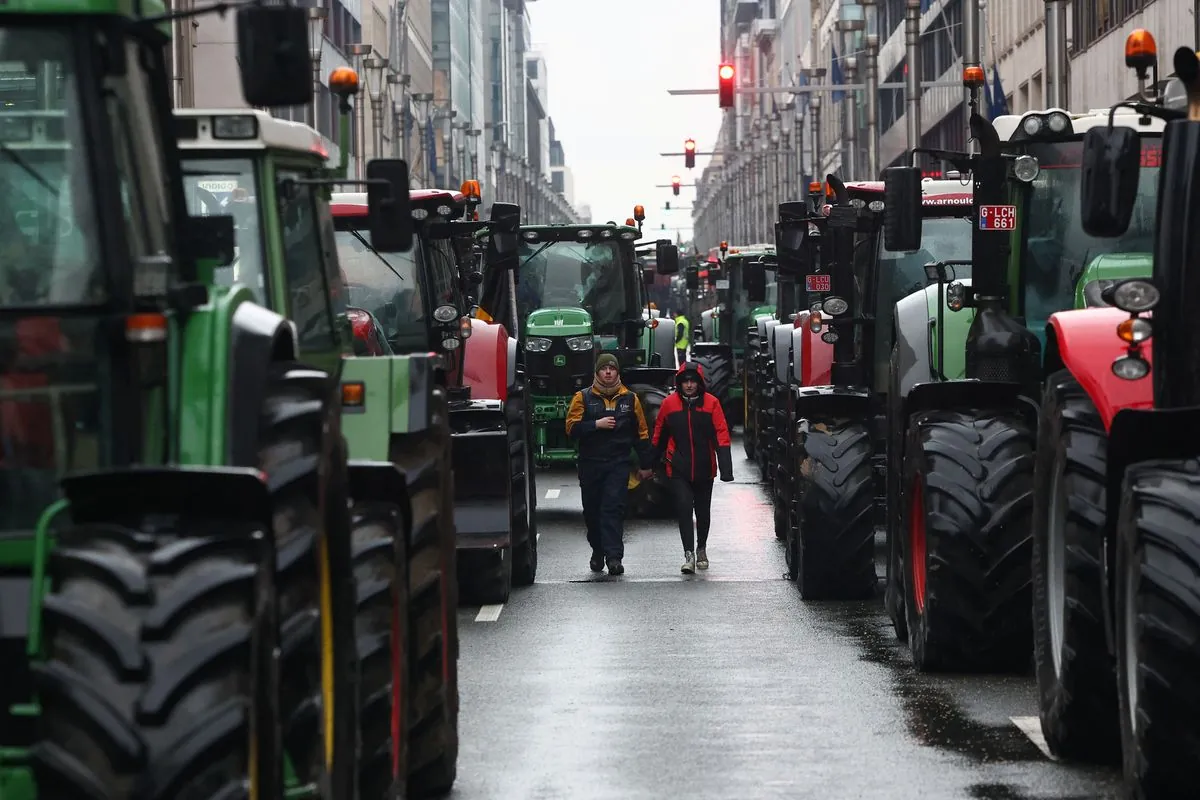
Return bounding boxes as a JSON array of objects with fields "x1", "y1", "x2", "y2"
[{"x1": 175, "y1": 104, "x2": 457, "y2": 796}]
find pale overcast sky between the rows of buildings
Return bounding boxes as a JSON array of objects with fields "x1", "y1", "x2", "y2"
[{"x1": 528, "y1": 0, "x2": 721, "y2": 240}]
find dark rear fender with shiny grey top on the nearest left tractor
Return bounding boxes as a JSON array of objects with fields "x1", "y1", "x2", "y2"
[{"x1": 226, "y1": 302, "x2": 302, "y2": 467}]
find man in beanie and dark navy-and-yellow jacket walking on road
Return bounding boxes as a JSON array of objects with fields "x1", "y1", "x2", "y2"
[{"x1": 566, "y1": 353, "x2": 654, "y2": 575}]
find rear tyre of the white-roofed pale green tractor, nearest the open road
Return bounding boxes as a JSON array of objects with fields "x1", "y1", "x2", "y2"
[{"x1": 390, "y1": 390, "x2": 458, "y2": 799}]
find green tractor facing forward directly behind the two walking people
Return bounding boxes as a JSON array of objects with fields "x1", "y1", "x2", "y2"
[{"x1": 476, "y1": 219, "x2": 678, "y2": 516}]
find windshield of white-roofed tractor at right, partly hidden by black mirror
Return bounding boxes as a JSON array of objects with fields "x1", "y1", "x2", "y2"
[{"x1": 1020, "y1": 134, "x2": 1162, "y2": 332}]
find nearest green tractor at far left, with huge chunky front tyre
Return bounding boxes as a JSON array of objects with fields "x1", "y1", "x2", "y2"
[{"x1": 0, "y1": 0, "x2": 422, "y2": 800}]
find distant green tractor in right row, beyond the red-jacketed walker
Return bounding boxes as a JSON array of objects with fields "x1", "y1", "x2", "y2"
[{"x1": 692, "y1": 242, "x2": 775, "y2": 425}]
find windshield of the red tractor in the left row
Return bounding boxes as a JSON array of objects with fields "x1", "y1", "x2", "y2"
[{"x1": 337, "y1": 230, "x2": 428, "y2": 353}]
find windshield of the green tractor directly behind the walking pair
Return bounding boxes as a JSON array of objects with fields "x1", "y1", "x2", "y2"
[{"x1": 517, "y1": 241, "x2": 632, "y2": 331}]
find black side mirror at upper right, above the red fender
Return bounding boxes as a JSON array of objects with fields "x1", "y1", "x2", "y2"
[{"x1": 1079, "y1": 126, "x2": 1141, "y2": 237}]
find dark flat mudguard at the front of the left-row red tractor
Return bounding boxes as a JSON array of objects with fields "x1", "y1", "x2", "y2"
[{"x1": 450, "y1": 401, "x2": 512, "y2": 551}]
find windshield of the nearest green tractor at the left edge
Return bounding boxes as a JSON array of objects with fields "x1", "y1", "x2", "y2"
[{"x1": 0, "y1": 32, "x2": 107, "y2": 307}]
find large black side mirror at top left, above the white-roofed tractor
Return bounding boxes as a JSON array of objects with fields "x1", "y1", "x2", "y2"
[{"x1": 236, "y1": 4, "x2": 312, "y2": 107}]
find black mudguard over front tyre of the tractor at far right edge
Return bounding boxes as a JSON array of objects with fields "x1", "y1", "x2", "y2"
[{"x1": 1100, "y1": 407, "x2": 1200, "y2": 652}]
